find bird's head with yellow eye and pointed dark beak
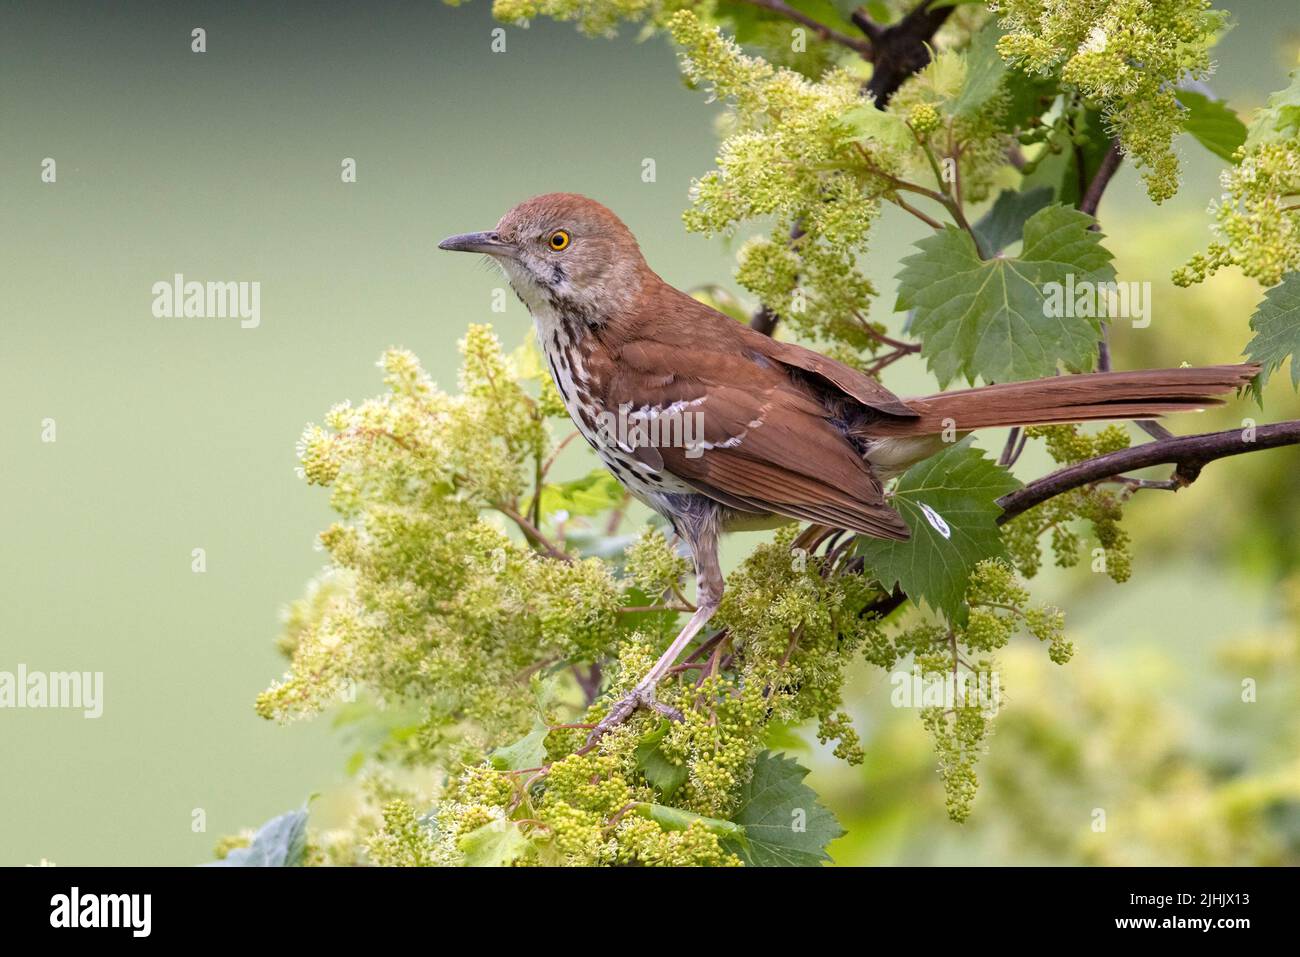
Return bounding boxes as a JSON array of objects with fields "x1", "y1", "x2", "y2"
[{"x1": 438, "y1": 192, "x2": 650, "y2": 324}]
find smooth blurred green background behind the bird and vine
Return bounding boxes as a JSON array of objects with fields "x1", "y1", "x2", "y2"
[{"x1": 0, "y1": 0, "x2": 1300, "y2": 865}]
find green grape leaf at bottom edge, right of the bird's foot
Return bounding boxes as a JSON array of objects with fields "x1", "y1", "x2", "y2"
[{"x1": 723, "y1": 752, "x2": 844, "y2": 867}]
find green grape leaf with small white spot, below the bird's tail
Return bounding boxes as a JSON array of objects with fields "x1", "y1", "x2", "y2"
[{"x1": 858, "y1": 438, "x2": 1021, "y2": 624}]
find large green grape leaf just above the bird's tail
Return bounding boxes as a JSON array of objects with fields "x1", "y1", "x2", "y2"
[{"x1": 894, "y1": 205, "x2": 1115, "y2": 386}]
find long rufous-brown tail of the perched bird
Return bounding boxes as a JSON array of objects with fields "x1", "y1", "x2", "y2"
[{"x1": 870, "y1": 364, "x2": 1260, "y2": 437}]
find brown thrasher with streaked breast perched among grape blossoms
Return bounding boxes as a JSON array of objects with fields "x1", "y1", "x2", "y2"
[{"x1": 438, "y1": 192, "x2": 1257, "y2": 740}]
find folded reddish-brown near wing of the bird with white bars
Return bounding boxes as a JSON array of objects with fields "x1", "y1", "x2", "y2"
[{"x1": 601, "y1": 339, "x2": 909, "y2": 540}]
